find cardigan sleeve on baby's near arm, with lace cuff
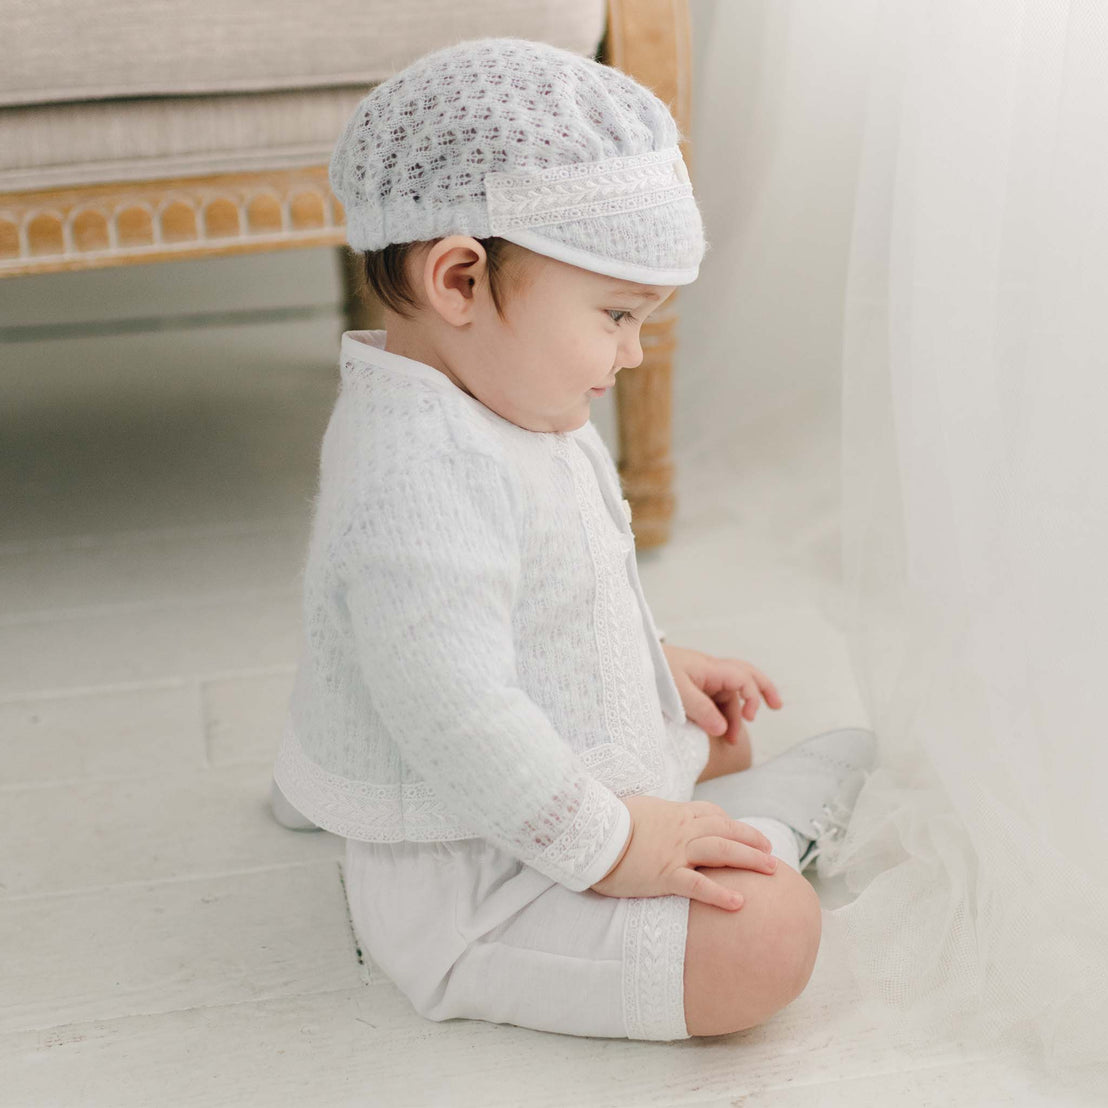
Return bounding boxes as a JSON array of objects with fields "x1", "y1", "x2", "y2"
[{"x1": 342, "y1": 452, "x2": 630, "y2": 891}]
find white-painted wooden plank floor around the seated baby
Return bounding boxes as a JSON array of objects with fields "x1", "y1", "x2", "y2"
[{"x1": 0, "y1": 263, "x2": 1094, "y2": 1108}]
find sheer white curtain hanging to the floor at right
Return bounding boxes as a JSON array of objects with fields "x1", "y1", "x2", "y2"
[{"x1": 678, "y1": 0, "x2": 1108, "y2": 1088}]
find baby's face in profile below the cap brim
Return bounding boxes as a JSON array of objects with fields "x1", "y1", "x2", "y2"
[{"x1": 387, "y1": 244, "x2": 676, "y2": 431}]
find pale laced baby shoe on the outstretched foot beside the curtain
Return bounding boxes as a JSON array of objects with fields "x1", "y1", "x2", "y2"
[{"x1": 705, "y1": 727, "x2": 878, "y2": 876}]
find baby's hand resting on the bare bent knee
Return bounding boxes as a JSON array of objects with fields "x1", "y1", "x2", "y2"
[{"x1": 589, "y1": 796, "x2": 777, "y2": 910}]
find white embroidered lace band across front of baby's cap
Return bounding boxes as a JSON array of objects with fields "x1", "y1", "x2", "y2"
[{"x1": 484, "y1": 146, "x2": 693, "y2": 235}]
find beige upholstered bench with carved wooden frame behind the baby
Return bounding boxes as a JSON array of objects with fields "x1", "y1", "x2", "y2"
[{"x1": 0, "y1": 0, "x2": 693, "y2": 548}]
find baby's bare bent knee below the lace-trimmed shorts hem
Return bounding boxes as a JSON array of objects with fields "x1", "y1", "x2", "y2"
[{"x1": 685, "y1": 864, "x2": 822, "y2": 1035}]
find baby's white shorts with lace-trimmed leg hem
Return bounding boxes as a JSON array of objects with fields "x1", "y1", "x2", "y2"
[{"x1": 345, "y1": 722, "x2": 708, "y2": 1040}]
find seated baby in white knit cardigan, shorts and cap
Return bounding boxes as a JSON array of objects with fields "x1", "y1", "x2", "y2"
[{"x1": 273, "y1": 38, "x2": 874, "y2": 1040}]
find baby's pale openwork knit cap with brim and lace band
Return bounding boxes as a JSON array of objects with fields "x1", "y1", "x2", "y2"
[{"x1": 330, "y1": 38, "x2": 708, "y2": 285}]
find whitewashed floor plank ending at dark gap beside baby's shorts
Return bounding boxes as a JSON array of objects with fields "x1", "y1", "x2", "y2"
[{"x1": 0, "y1": 862, "x2": 362, "y2": 1032}]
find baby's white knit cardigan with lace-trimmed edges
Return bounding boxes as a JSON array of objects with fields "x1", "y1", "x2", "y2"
[{"x1": 274, "y1": 330, "x2": 708, "y2": 890}]
